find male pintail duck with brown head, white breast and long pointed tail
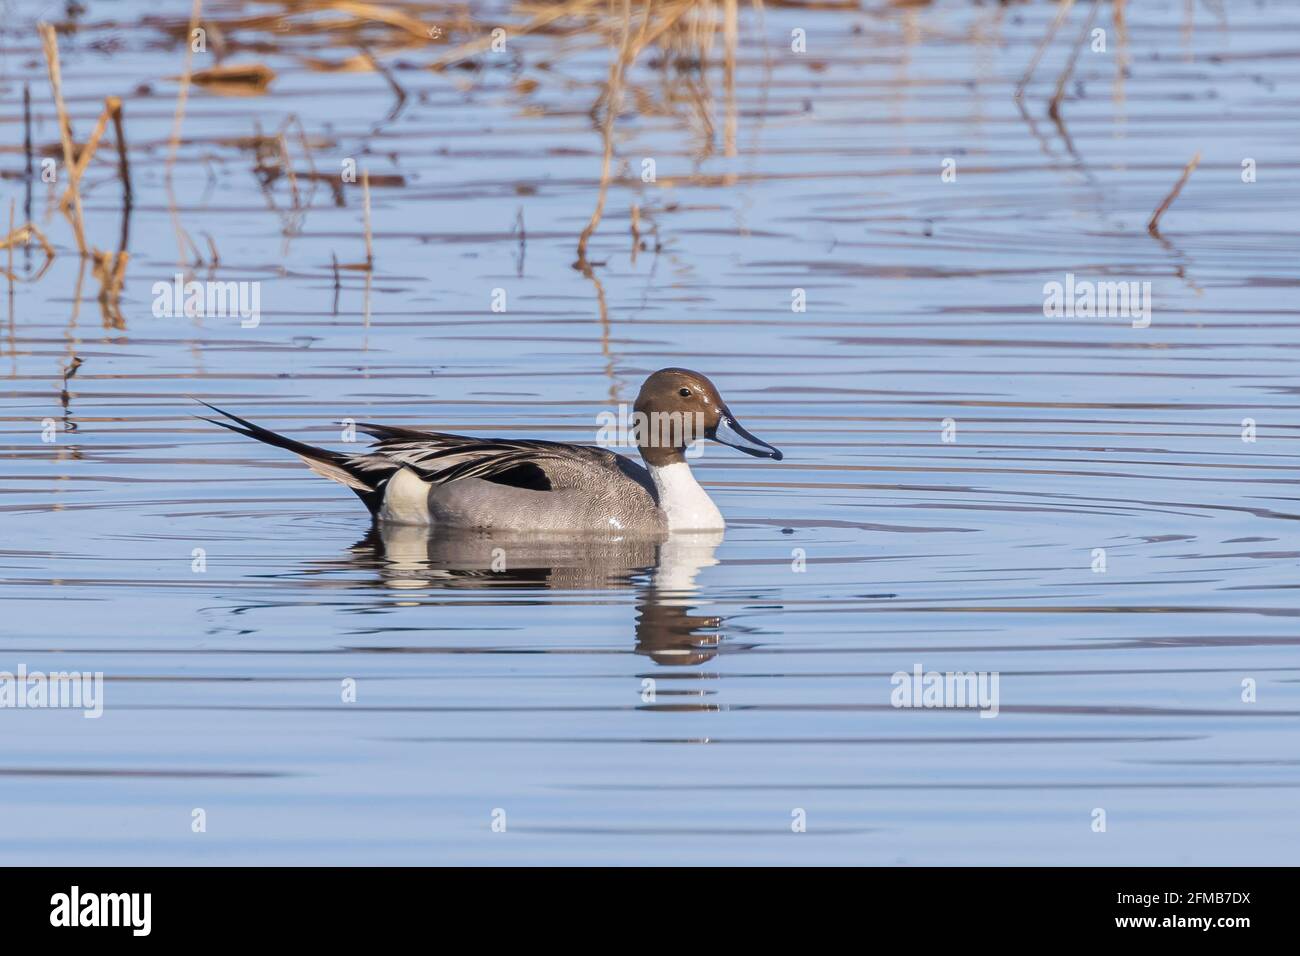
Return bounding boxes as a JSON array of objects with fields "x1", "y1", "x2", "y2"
[{"x1": 204, "y1": 368, "x2": 781, "y2": 535}]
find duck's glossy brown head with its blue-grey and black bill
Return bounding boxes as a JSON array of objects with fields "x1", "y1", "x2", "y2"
[{"x1": 634, "y1": 368, "x2": 781, "y2": 466}]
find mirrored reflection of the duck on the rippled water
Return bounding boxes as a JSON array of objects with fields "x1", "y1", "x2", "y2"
[{"x1": 352, "y1": 522, "x2": 724, "y2": 665}]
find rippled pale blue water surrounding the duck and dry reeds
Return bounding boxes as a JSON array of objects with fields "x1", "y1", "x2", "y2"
[{"x1": 0, "y1": 1, "x2": 1300, "y2": 864}]
